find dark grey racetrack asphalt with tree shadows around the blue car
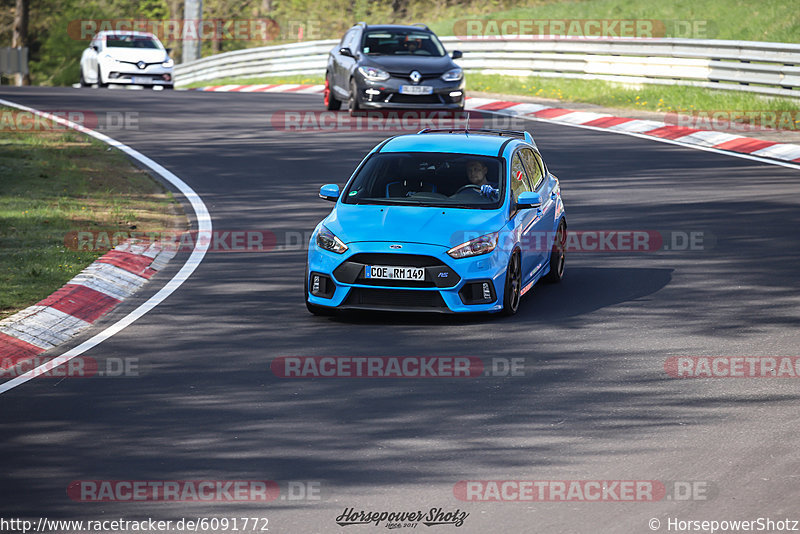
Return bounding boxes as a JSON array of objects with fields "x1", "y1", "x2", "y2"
[{"x1": 0, "y1": 88, "x2": 800, "y2": 533}]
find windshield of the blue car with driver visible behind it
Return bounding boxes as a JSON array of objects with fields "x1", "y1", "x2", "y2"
[{"x1": 342, "y1": 152, "x2": 503, "y2": 209}]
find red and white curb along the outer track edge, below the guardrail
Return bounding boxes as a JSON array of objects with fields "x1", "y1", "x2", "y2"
[{"x1": 189, "y1": 84, "x2": 800, "y2": 163}]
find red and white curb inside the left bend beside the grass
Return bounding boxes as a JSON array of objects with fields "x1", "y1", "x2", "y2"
[{"x1": 0, "y1": 242, "x2": 175, "y2": 370}]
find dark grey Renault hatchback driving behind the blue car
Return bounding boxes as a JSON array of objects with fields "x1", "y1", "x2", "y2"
[{"x1": 325, "y1": 22, "x2": 464, "y2": 112}]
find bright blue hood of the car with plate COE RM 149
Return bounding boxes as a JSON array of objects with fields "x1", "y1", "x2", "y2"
[{"x1": 325, "y1": 204, "x2": 505, "y2": 248}]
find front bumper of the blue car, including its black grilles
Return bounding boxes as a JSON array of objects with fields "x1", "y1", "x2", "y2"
[{"x1": 307, "y1": 242, "x2": 509, "y2": 313}]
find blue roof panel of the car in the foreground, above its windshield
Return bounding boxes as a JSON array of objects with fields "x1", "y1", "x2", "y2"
[{"x1": 380, "y1": 133, "x2": 519, "y2": 157}]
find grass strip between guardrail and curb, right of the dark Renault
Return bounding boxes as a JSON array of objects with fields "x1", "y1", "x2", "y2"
[{"x1": 467, "y1": 74, "x2": 800, "y2": 116}]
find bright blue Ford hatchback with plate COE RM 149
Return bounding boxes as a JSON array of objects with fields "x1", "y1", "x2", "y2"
[{"x1": 305, "y1": 129, "x2": 567, "y2": 315}]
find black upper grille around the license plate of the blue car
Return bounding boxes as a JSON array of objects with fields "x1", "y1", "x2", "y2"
[{"x1": 333, "y1": 253, "x2": 461, "y2": 288}]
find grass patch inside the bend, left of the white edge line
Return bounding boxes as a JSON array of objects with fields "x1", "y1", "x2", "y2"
[{"x1": 0, "y1": 108, "x2": 185, "y2": 319}]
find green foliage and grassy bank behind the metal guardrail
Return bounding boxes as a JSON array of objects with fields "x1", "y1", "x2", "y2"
[{"x1": 6, "y1": 0, "x2": 800, "y2": 85}]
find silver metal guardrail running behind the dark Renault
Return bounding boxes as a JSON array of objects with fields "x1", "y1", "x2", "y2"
[{"x1": 175, "y1": 36, "x2": 800, "y2": 98}]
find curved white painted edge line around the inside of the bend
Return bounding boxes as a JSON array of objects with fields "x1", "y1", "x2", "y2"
[{"x1": 0, "y1": 98, "x2": 212, "y2": 395}]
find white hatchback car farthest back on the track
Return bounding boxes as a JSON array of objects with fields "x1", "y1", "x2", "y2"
[{"x1": 81, "y1": 31, "x2": 174, "y2": 89}]
